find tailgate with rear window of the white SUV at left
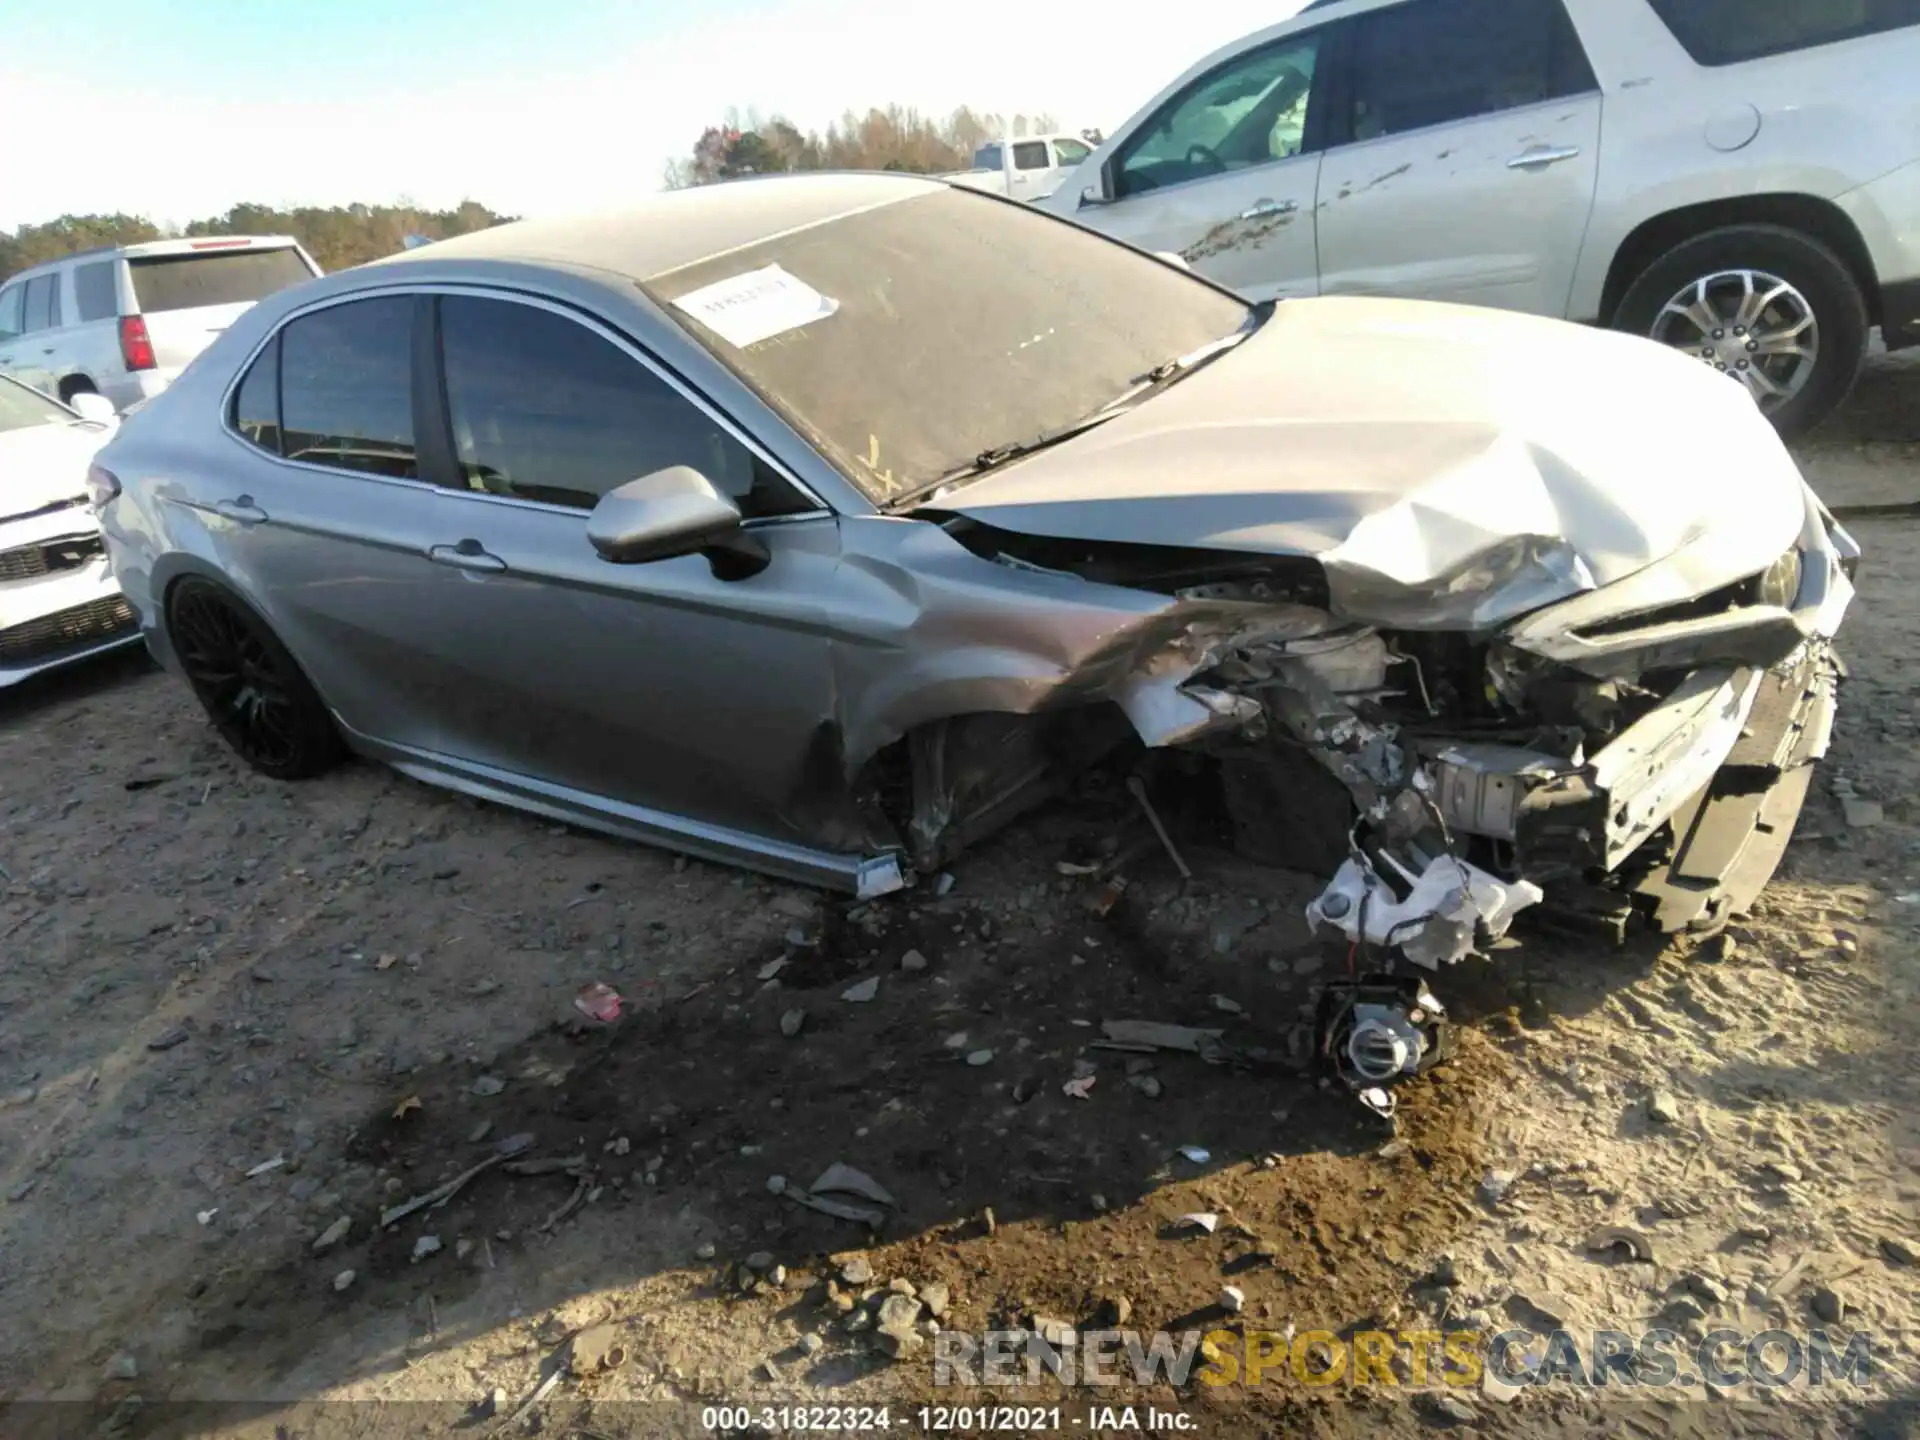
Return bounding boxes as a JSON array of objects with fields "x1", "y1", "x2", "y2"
[{"x1": 127, "y1": 240, "x2": 313, "y2": 371}]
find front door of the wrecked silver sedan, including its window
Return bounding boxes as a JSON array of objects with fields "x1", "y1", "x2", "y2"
[{"x1": 412, "y1": 296, "x2": 839, "y2": 841}]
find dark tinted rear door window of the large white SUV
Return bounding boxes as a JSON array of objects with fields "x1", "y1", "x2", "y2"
[{"x1": 1340, "y1": 0, "x2": 1596, "y2": 140}]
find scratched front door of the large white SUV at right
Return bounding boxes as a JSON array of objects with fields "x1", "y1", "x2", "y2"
[{"x1": 1075, "y1": 29, "x2": 1329, "y2": 300}]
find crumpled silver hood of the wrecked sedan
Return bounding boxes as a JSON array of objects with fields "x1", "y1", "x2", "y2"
[{"x1": 944, "y1": 298, "x2": 1807, "y2": 630}]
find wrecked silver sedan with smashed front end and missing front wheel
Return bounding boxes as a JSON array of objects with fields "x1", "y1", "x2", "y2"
[{"x1": 92, "y1": 175, "x2": 1859, "y2": 1081}]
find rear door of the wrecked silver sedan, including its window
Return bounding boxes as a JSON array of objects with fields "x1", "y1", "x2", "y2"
[{"x1": 211, "y1": 294, "x2": 463, "y2": 751}]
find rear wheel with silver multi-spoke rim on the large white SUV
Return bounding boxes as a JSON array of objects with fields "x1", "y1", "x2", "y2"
[{"x1": 1613, "y1": 225, "x2": 1870, "y2": 436}]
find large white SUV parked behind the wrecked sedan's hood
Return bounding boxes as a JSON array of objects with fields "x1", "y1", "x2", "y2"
[{"x1": 1041, "y1": 0, "x2": 1920, "y2": 432}]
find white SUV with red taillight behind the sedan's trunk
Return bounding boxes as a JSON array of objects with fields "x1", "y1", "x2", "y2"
[{"x1": 0, "y1": 234, "x2": 321, "y2": 411}]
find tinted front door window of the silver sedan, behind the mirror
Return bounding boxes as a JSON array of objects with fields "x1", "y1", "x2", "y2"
[{"x1": 440, "y1": 296, "x2": 814, "y2": 520}]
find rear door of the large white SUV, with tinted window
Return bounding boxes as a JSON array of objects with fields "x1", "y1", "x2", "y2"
[{"x1": 1317, "y1": 0, "x2": 1601, "y2": 315}]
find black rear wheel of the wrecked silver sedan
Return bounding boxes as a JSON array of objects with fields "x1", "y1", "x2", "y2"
[{"x1": 167, "y1": 576, "x2": 346, "y2": 780}]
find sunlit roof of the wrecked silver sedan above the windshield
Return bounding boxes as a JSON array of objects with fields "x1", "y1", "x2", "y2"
[{"x1": 367, "y1": 171, "x2": 944, "y2": 280}]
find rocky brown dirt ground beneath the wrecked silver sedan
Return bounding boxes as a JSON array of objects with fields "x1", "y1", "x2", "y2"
[{"x1": 0, "y1": 361, "x2": 1920, "y2": 1436}]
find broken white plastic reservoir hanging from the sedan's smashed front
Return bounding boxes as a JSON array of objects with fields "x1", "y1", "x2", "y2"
[{"x1": 1308, "y1": 854, "x2": 1544, "y2": 970}]
